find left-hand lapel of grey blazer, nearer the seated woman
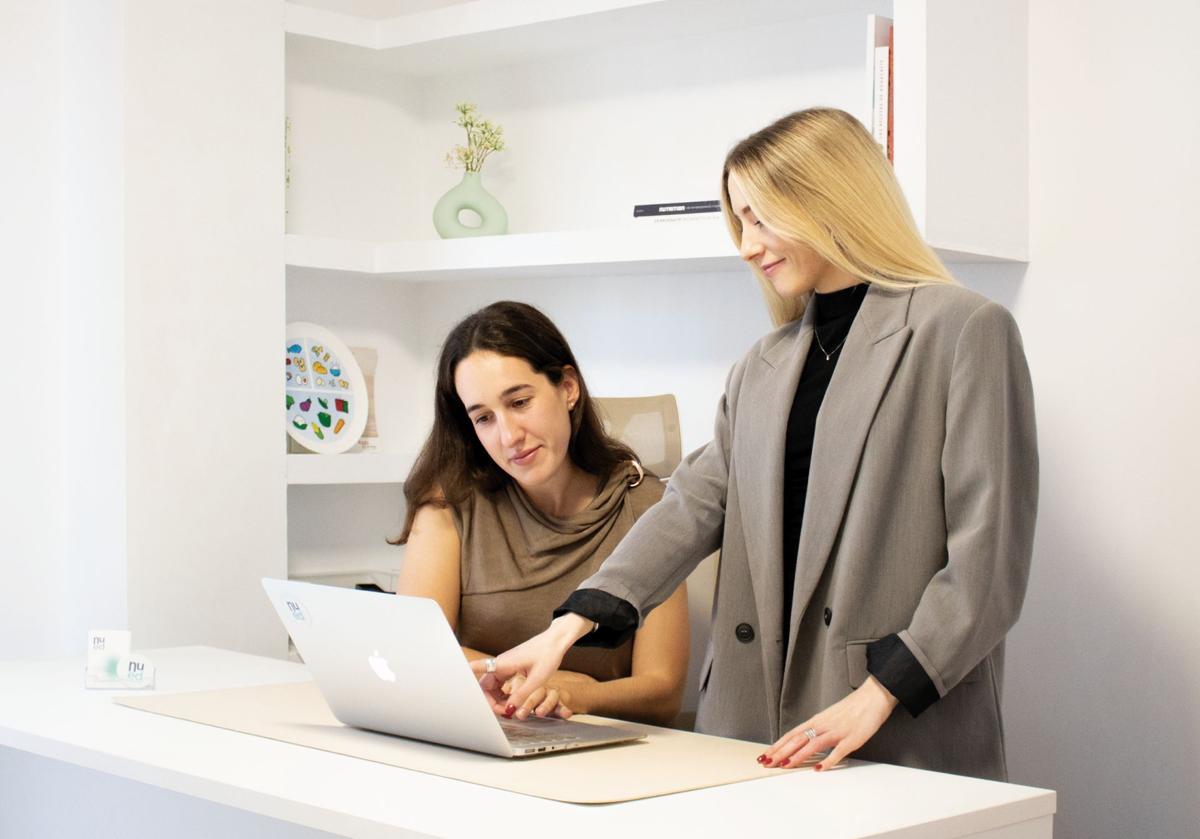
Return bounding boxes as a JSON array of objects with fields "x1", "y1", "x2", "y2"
[{"x1": 738, "y1": 307, "x2": 812, "y2": 731}]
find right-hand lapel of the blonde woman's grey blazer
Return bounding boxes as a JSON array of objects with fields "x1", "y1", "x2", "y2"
[{"x1": 775, "y1": 286, "x2": 912, "y2": 684}]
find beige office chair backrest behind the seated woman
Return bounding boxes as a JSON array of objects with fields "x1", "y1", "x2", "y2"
[{"x1": 595, "y1": 394, "x2": 720, "y2": 731}]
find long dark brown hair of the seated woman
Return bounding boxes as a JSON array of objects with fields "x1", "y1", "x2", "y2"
[{"x1": 392, "y1": 300, "x2": 635, "y2": 545}]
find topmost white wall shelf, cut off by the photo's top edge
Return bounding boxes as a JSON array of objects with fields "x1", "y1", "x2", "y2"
[{"x1": 283, "y1": 0, "x2": 878, "y2": 76}]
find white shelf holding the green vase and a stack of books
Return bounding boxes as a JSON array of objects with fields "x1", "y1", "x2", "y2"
[{"x1": 284, "y1": 217, "x2": 742, "y2": 282}]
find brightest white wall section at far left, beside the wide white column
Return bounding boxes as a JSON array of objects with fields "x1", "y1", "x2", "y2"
[{"x1": 0, "y1": 0, "x2": 126, "y2": 658}]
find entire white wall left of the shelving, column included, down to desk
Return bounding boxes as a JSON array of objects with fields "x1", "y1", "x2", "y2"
[{"x1": 0, "y1": 0, "x2": 286, "y2": 658}]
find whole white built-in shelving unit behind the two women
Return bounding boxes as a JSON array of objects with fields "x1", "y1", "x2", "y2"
[{"x1": 283, "y1": 0, "x2": 1027, "y2": 619}]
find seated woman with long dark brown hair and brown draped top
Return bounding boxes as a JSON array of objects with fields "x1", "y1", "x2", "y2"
[{"x1": 397, "y1": 301, "x2": 688, "y2": 725}]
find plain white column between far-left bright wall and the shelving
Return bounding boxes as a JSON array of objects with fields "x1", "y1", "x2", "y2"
[{"x1": 125, "y1": 0, "x2": 287, "y2": 655}]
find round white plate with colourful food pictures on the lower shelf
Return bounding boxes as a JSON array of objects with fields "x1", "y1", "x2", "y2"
[{"x1": 283, "y1": 320, "x2": 367, "y2": 455}]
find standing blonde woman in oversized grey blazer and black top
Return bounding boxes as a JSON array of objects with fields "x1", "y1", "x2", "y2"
[{"x1": 476, "y1": 108, "x2": 1038, "y2": 779}]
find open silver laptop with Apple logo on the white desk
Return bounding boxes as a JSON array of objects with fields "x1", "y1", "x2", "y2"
[{"x1": 263, "y1": 579, "x2": 646, "y2": 757}]
